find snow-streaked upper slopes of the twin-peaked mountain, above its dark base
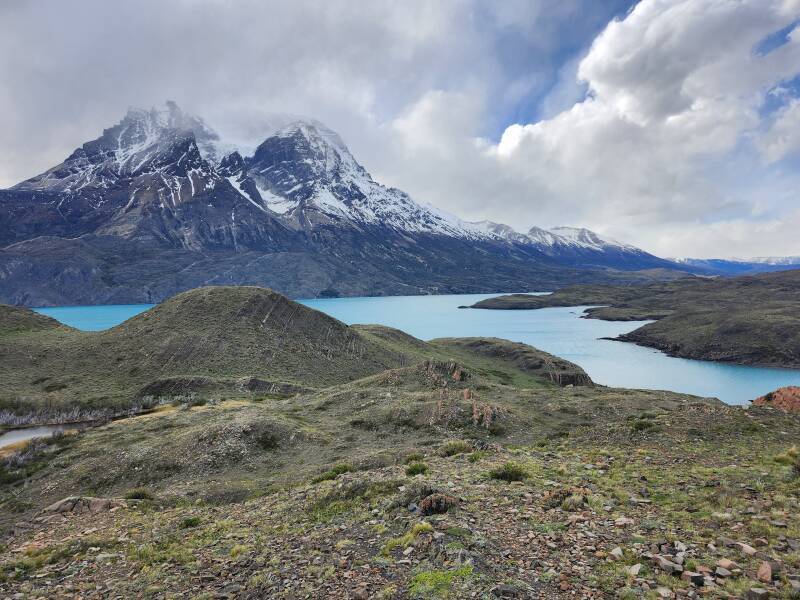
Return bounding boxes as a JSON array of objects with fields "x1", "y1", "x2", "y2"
[{"x1": 4, "y1": 102, "x2": 655, "y2": 260}]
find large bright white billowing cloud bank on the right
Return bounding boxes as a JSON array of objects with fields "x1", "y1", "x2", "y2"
[{"x1": 368, "y1": 0, "x2": 800, "y2": 256}]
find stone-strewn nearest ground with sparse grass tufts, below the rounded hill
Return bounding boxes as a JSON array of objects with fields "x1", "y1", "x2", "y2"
[{"x1": 0, "y1": 403, "x2": 800, "y2": 598}]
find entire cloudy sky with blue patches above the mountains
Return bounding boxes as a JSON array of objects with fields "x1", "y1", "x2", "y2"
[{"x1": 0, "y1": 0, "x2": 800, "y2": 258}]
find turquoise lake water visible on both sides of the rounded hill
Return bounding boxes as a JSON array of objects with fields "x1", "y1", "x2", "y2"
[{"x1": 36, "y1": 294, "x2": 800, "y2": 404}]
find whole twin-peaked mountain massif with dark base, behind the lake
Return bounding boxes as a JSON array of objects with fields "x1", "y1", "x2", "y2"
[{"x1": 0, "y1": 103, "x2": 688, "y2": 305}]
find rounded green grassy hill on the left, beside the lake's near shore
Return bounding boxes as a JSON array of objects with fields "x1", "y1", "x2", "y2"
[{"x1": 0, "y1": 287, "x2": 588, "y2": 420}]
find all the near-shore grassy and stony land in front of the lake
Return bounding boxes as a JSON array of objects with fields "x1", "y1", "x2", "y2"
[{"x1": 0, "y1": 287, "x2": 800, "y2": 599}]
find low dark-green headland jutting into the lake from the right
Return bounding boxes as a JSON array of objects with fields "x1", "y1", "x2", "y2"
[{"x1": 473, "y1": 270, "x2": 800, "y2": 368}]
